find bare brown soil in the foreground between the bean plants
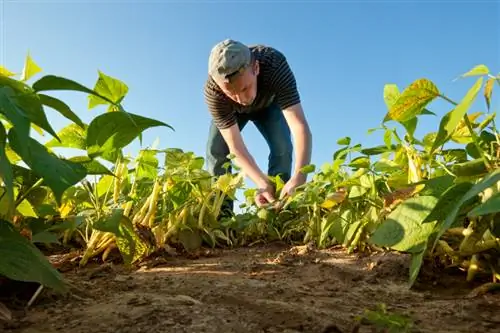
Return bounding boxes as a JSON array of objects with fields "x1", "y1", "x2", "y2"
[{"x1": 0, "y1": 244, "x2": 500, "y2": 333}]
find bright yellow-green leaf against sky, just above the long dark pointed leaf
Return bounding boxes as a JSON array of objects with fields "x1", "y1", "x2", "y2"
[{"x1": 88, "y1": 71, "x2": 128, "y2": 109}]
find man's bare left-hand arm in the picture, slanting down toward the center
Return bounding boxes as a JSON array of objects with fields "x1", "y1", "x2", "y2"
[{"x1": 220, "y1": 124, "x2": 269, "y2": 189}]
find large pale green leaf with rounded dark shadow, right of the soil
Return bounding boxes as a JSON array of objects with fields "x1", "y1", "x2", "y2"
[{"x1": 370, "y1": 196, "x2": 438, "y2": 253}]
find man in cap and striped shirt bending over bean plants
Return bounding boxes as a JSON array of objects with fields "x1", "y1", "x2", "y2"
[{"x1": 204, "y1": 39, "x2": 312, "y2": 215}]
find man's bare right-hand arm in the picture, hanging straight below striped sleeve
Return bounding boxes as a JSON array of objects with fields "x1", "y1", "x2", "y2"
[{"x1": 283, "y1": 103, "x2": 312, "y2": 184}]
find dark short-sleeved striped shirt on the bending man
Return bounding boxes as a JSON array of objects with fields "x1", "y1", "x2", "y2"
[{"x1": 204, "y1": 45, "x2": 300, "y2": 129}]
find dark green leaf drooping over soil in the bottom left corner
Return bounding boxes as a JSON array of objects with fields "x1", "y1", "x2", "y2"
[{"x1": 0, "y1": 220, "x2": 67, "y2": 292}]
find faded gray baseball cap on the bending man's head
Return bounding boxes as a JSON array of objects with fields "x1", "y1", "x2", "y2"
[{"x1": 208, "y1": 39, "x2": 252, "y2": 80}]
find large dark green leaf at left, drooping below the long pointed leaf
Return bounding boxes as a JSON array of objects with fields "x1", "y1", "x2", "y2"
[{"x1": 9, "y1": 128, "x2": 86, "y2": 204}]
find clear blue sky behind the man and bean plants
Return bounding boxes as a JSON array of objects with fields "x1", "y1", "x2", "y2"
[{"x1": 0, "y1": 0, "x2": 500, "y2": 197}]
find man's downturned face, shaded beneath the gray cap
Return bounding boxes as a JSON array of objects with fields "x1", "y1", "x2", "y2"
[{"x1": 217, "y1": 61, "x2": 259, "y2": 105}]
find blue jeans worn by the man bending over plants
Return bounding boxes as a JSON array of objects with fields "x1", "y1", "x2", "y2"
[{"x1": 207, "y1": 104, "x2": 293, "y2": 209}]
